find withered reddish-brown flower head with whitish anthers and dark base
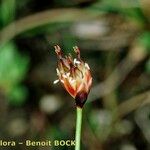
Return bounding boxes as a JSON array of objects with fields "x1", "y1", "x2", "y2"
[{"x1": 54, "y1": 45, "x2": 92, "y2": 108}]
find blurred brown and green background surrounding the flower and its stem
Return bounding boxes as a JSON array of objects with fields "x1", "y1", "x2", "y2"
[{"x1": 0, "y1": 0, "x2": 150, "y2": 150}]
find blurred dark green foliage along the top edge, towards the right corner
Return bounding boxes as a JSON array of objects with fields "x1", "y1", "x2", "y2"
[{"x1": 91, "y1": 0, "x2": 146, "y2": 24}]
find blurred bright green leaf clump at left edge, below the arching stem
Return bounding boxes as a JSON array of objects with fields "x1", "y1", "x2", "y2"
[{"x1": 0, "y1": 43, "x2": 29, "y2": 105}]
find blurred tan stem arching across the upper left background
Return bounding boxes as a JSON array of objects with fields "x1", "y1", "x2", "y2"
[{"x1": 0, "y1": 8, "x2": 99, "y2": 46}]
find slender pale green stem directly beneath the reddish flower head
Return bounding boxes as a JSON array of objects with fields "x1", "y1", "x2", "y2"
[{"x1": 75, "y1": 107, "x2": 82, "y2": 150}]
